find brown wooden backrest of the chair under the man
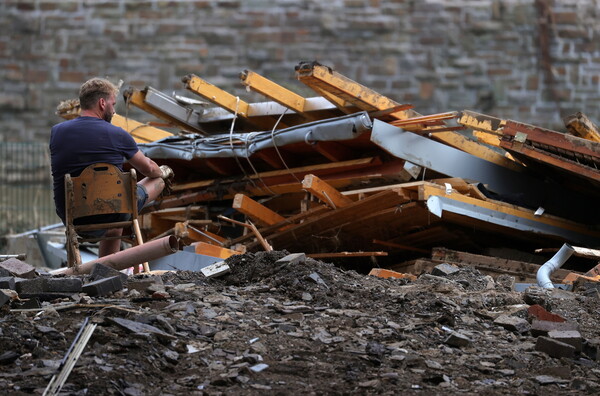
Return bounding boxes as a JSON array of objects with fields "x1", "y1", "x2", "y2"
[{"x1": 65, "y1": 163, "x2": 137, "y2": 219}]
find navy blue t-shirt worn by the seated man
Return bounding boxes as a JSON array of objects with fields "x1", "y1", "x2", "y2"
[{"x1": 50, "y1": 117, "x2": 139, "y2": 223}]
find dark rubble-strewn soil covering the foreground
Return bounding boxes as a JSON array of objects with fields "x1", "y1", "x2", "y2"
[{"x1": 0, "y1": 252, "x2": 600, "y2": 396}]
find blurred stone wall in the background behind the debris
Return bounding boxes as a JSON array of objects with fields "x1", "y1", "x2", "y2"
[{"x1": 0, "y1": 0, "x2": 600, "y2": 141}]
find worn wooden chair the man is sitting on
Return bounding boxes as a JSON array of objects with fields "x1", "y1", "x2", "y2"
[{"x1": 65, "y1": 163, "x2": 148, "y2": 272}]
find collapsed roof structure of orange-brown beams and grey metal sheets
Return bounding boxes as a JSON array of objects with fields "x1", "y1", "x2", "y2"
[{"x1": 58, "y1": 62, "x2": 600, "y2": 281}]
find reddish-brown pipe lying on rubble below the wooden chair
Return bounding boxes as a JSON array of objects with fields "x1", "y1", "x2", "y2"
[{"x1": 50, "y1": 235, "x2": 179, "y2": 275}]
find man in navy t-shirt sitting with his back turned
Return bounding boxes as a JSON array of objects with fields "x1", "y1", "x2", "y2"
[{"x1": 50, "y1": 78, "x2": 173, "y2": 257}]
